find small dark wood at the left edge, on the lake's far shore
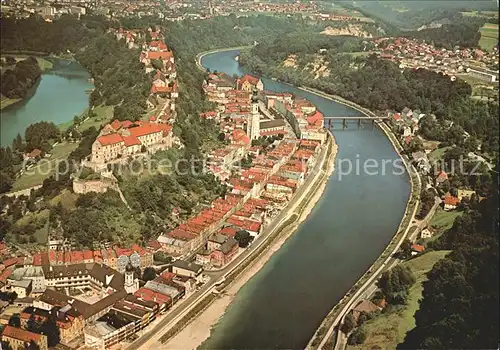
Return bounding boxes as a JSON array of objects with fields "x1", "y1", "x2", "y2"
[{"x1": 0, "y1": 56, "x2": 42, "y2": 99}]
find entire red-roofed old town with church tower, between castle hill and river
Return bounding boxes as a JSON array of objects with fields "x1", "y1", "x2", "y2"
[{"x1": 150, "y1": 73, "x2": 323, "y2": 268}]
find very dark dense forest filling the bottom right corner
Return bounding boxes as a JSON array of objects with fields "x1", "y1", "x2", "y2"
[{"x1": 398, "y1": 190, "x2": 499, "y2": 349}]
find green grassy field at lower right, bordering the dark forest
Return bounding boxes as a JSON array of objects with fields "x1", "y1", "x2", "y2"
[{"x1": 347, "y1": 251, "x2": 449, "y2": 350}]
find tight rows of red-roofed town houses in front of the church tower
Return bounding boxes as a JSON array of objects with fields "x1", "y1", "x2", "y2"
[{"x1": 150, "y1": 135, "x2": 320, "y2": 268}]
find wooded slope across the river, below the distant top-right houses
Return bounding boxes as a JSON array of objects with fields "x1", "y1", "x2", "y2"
[{"x1": 240, "y1": 33, "x2": 499, "y2": 158}]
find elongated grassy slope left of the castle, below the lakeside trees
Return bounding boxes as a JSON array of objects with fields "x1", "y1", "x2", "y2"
[{"x1": 12, "y1": 142, "x2": 78, "y2": 191}]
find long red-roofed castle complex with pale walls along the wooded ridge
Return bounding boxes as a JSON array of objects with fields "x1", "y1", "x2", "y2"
[{"x1": 84, "y1": 28, "x2": 179, "y2": 171}]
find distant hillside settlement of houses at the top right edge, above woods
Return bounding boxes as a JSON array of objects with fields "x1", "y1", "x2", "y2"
[{"x1": 373, "y1": 37, "x2": 498, "y2": 83}]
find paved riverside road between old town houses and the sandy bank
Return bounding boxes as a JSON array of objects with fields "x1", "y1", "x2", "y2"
[{"x1": 127, "y1": 138, "x2": 327, "y2": 349}]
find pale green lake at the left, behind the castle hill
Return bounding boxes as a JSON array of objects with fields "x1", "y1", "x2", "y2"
[{"x1": 0, "y1": 58, "x2": 93, "y2": 146}]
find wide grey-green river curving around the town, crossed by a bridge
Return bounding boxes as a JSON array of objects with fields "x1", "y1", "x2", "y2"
[{"x1": 202, "y1": 51, "x2": 410, "y2": 349}]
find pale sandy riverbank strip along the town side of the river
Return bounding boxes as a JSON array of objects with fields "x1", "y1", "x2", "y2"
[{"x1": 162, "y1": 138, "x2": 338, "y2": 350}]
